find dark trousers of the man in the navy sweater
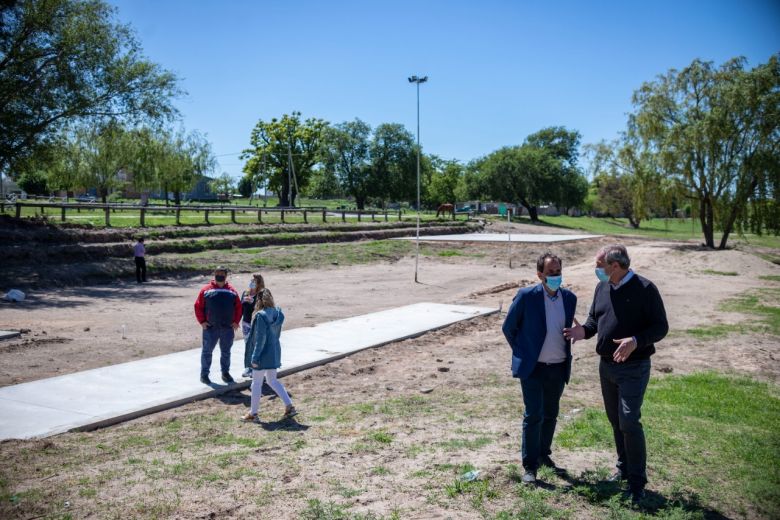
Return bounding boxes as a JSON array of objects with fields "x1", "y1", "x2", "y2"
[{"x1": 599, "y1": 359, "x2": 650, "y2": 489}]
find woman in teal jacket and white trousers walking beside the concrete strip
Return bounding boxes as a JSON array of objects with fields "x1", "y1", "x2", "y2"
[{"x1": 241, "y1": 289, "x2": 298, "y2": 422}]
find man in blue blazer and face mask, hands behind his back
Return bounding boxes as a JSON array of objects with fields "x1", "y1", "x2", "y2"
[{"x1": 502, "y1": 253, "x2": 577, "y2": 484}]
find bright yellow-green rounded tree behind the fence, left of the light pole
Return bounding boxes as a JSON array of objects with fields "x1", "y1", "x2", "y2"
[{"x1": 241, "y1": 112, "x2": 328, "y2": 206}]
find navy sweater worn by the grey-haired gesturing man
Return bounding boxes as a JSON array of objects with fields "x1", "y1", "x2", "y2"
[{"x1": 583, "y1": 273, "x2": 669, "y2": 361}]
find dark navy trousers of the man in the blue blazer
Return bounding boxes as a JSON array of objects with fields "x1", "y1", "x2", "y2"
[{"x1": 520, "y1": 363, "x2": 566, "y2": 471}]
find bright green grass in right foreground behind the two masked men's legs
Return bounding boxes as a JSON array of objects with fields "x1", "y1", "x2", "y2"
[{"x1": 557, "y1": 372, "x2": 780, "y2": 517}]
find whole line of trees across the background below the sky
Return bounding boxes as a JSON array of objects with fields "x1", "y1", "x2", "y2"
[{"x1": 0, "y1": 0, "x2": 780, "y2": 248}]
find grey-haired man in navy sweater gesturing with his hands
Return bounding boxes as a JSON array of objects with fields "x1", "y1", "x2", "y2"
[{"x1": 564, "y1": 244, "x2": 669, "y2": 502}]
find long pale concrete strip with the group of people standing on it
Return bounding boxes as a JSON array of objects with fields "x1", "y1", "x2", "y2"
[{"x1": 0, "y1": 303, "x2": 497, "y2": 440}]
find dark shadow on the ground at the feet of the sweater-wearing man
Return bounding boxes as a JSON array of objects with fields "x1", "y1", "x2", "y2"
[{"x1": 560, "y1": 472, "x2": 728, "y2": 520}]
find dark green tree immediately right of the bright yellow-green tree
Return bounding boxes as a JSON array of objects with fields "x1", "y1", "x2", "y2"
[{"x1": 322, "y1": 119, "x2": 371, "y2": 209}]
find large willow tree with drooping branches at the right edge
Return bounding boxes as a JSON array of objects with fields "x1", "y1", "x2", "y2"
[{"x1": 633, "y1": 55, "x2": 780, "y2": 249}]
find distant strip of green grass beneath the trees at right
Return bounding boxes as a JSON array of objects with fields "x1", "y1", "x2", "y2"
[{"x1": 524, "y1": 215, "x2": 780, "y2": 248}]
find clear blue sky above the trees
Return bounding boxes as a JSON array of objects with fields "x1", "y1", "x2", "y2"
[{"x1": 110, "y1": 0, "x2": 780, "y2": 177}]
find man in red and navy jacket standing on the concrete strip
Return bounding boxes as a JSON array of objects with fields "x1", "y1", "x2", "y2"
[{"x1": 195, "y1": 267, "x2": 241, "y2": 385}]
